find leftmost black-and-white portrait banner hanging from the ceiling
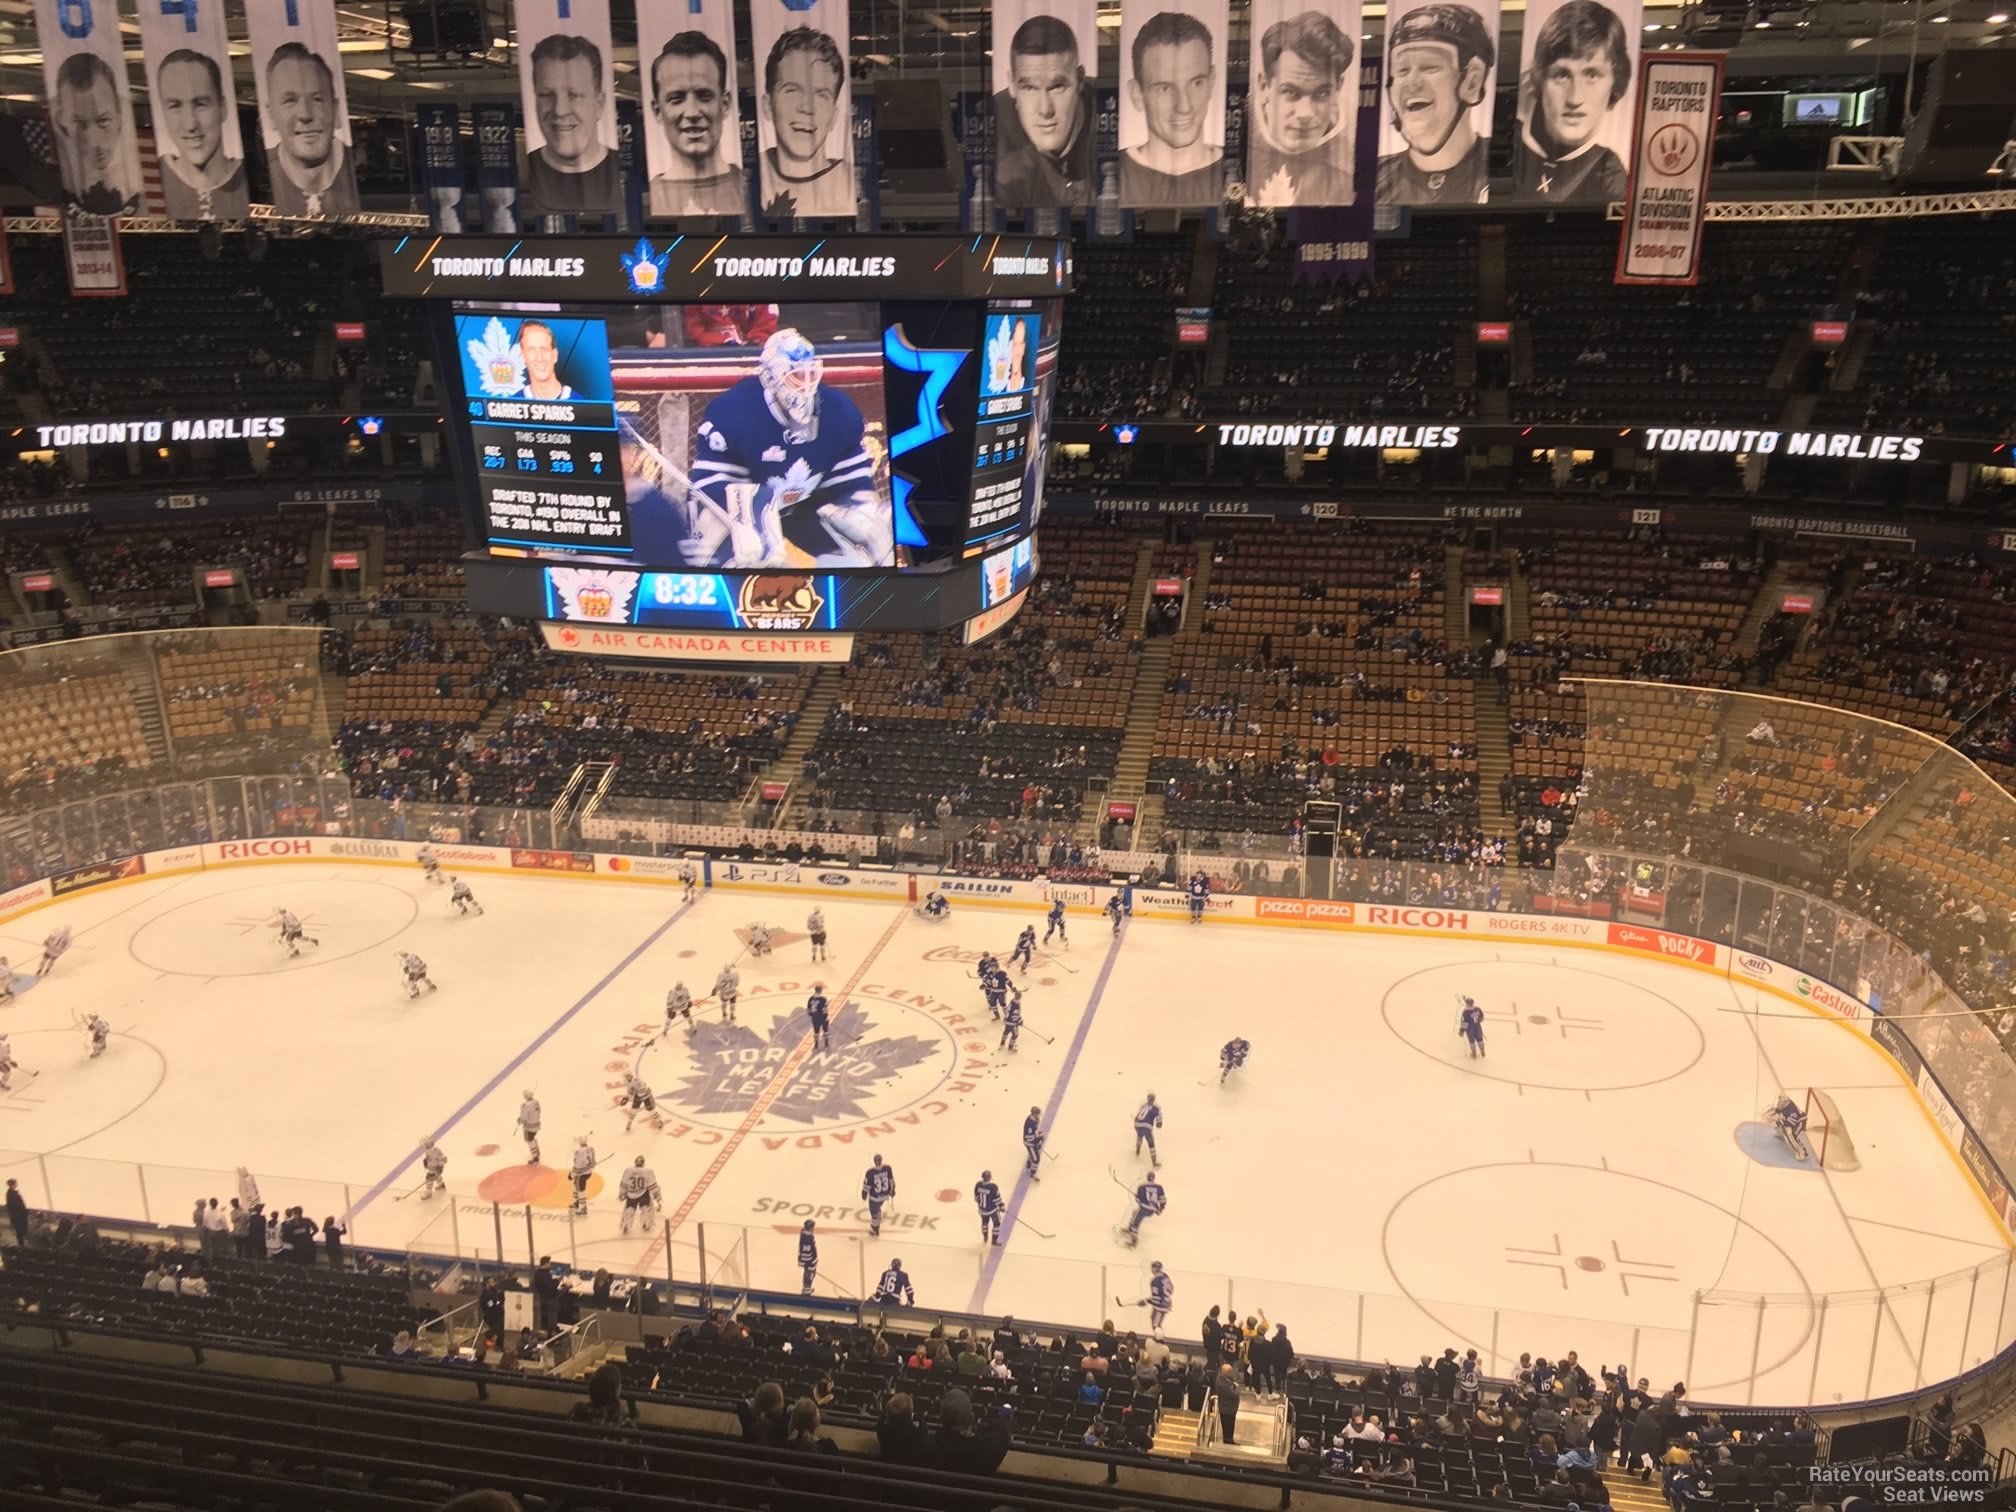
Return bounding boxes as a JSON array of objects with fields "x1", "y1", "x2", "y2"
[{"x1": 34, "y1": 0, "x2": 141, "y2": 216}]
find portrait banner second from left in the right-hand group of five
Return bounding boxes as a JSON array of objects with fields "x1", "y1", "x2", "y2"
[{"x1": 1119, "y1": 0, "x2": 1228, "y2": 210}]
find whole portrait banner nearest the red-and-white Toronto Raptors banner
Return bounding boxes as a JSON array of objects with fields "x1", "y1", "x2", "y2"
[{"x1": 1512, "y1": 0, "x2": 1645, "y2": 206}]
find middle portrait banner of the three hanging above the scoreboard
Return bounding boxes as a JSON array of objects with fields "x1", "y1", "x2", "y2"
[{"x1": 637, "y1": 0, "x2": 750, "y2": 216}]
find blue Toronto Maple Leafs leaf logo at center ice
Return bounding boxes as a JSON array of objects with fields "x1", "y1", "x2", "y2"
[{"x1": 669, "y1": 1002, "x2": 937, "y2": 1125}]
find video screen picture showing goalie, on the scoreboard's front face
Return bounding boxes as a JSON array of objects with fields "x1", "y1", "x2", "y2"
[{"x1": 609, "y1": 304, "x2": 897, "y2": 569}]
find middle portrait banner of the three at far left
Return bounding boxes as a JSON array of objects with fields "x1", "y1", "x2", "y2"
[{"x1": 139, "y1": 0, "x2": 252, "y2": 220}]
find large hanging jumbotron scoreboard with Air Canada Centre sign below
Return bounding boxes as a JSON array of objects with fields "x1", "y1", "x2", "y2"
[{"x1": 381, "y1": 236, "x2": 1070, "y2": 661}]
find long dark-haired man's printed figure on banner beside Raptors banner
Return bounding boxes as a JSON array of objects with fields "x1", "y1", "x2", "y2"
[{"x1": 1512, "y1": 0, "x2": 1631, "y2": 204}]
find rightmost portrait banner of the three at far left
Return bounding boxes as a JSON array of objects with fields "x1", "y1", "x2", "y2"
[{"x1": 246, "y1": 0, "x2": 357, "y2": 216}]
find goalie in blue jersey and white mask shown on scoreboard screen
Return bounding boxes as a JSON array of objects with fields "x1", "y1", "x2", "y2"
[{"x1": 677, "y1": 327, "x2": 895, "y2": 566}]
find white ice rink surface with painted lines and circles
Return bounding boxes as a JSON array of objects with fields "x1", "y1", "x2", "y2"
[{"x1": 0, "y1": 863, "x2": 2016, "y2": 1403}]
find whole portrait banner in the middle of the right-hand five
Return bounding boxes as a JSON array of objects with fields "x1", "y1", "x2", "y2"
[{"x1": 1246, "y1": 0, "x2": 1361, "y2": 210}]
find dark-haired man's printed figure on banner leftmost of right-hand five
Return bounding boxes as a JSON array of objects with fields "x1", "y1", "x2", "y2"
[{"x1": 994, "y1": 16, "x2": 1097, "y2": 210}]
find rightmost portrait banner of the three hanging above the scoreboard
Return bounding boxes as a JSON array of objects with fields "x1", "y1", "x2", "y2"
[{"x1": 750, "y1": 0, "x2": 855, "y2": 220}]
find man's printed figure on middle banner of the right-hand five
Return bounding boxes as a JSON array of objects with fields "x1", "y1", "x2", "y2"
[{"x1": 1246, "y1": 10, "x2": 1359, "y2": 208}]
